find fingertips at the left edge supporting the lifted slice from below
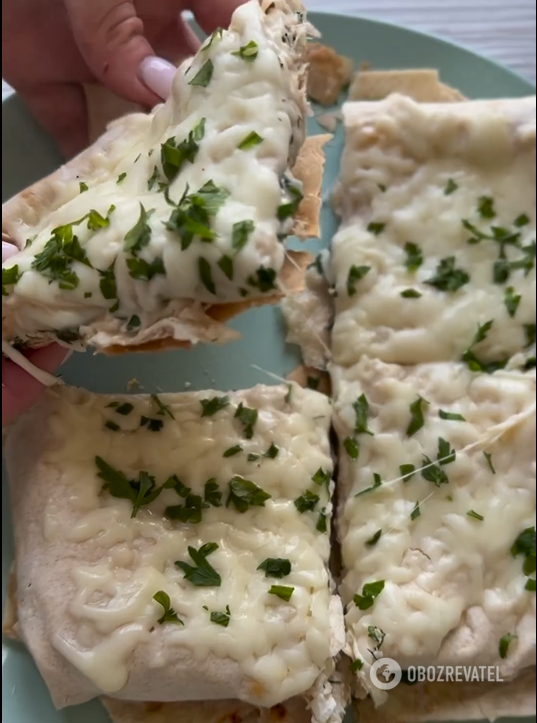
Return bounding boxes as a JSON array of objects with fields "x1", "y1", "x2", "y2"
[{"x1": 2, "y1": 241, "x2": 69, "y2": 427}]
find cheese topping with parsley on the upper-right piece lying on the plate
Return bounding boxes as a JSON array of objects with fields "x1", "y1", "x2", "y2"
[{"x1": 332, "y1": 96, "x2": 536, "y2": 367}]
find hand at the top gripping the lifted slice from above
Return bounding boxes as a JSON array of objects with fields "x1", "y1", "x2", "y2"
[{"x1": 2, "y1": 0, "x2": 243, "y2": 158}]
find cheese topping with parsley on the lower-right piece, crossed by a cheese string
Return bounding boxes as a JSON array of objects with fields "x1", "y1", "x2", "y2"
[{"x1": 333, "y1": 358, "x2": 537, "y2": 702}]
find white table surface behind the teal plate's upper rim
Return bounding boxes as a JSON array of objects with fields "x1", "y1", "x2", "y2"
[{"x1": 2, "y1": 0, "x2": 536, "y2": 103}]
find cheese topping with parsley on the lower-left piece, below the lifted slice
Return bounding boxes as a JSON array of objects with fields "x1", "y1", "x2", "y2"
[{"x1": 8, "y1": 386, "x2": 342, "y2": 707}]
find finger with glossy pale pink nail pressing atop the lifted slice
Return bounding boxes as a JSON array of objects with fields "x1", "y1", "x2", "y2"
[{"x1": 65, "y1": 0, "x2": 178, "y2": 108}]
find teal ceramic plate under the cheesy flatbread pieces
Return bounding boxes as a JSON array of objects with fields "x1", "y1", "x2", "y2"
[{"x1": 2, "y1": 13, "x2": 535, "y2": 723}]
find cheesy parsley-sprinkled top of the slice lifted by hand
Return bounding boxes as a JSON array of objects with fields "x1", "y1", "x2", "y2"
[{"x1": 2, "y1": 0, "x2": 309, "y2": 343}]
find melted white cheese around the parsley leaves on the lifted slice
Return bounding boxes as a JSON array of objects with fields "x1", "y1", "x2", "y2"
[{"x1": 3, "y1": 0, "x2": 308, "y2": 346}]
